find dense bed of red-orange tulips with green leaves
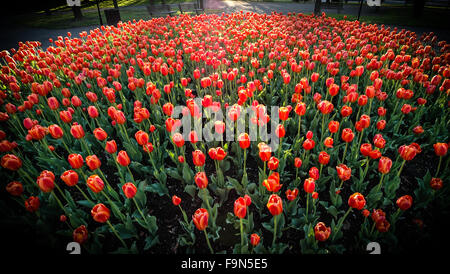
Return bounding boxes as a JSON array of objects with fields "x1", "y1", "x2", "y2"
[{"x1": 0, "y1": 13, "x2": 450, "y2": 254}]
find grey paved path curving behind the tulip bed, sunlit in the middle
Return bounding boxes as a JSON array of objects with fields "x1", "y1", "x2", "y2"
[{"x1": 0, "y1": 0, "x2": 450, "y2": 50}]
